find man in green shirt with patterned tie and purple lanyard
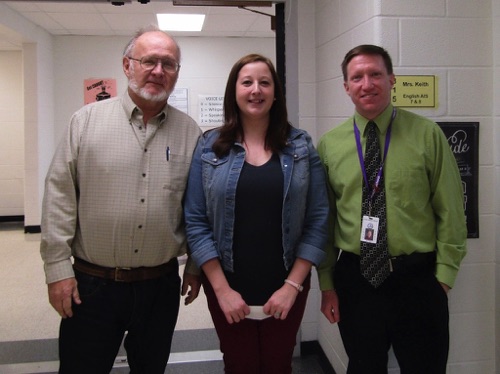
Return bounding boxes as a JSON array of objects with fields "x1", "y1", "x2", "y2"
[{"x1": 318, "y1": 45, "x2": 467, "y2": 374}]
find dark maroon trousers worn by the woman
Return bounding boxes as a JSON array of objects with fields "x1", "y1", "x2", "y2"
[{"x1": 202, "y1": 276, "x2": 311, "y2": 374}]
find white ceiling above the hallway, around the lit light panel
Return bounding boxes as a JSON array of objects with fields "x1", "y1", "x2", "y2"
[{"x1": 0, "y1": 0, "x2": 276, "y2": 50}]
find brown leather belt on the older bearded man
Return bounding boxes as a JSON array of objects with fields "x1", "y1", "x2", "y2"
[{"x1": 73, "y1": 257, "x2": 179, "y2": 282}]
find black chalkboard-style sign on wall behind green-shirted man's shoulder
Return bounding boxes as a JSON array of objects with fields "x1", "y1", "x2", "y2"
[{"x1": 437, "y1": 122, "x2": 479, "y2": 238}]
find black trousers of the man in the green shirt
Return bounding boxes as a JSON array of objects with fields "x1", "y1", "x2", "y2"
[{"x1": 335, "y1": 252, "x2": 449, "y2": 374}]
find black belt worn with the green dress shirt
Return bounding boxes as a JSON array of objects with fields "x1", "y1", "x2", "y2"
[{"x1": 340, "y1": 251, "x2": 436, "y2": 273}]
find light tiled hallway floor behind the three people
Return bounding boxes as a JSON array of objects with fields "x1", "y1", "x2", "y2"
[{"x1": 0, "y1": 222, "x2": 333, "y2": 374}]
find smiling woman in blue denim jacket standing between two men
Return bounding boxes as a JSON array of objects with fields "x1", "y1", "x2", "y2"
[{"x1": 185, "y1": 54, "x2": 328, "y2": 374}]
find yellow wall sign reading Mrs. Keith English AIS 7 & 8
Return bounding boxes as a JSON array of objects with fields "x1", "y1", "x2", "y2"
[{"x1": 392, "y1": 75, "x2": 436, "y2": 108}]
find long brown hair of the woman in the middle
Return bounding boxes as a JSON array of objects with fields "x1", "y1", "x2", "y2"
[{"x1": 212, "y1": 53, "x2": 290, "y2": 157}]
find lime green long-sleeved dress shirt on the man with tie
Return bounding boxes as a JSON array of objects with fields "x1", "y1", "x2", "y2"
[{"x1": 317, "y1": 105, "x2": 467, "y2": 290}]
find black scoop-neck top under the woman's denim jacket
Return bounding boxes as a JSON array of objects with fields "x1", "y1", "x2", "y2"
[{"x1": 226, "y1": 154, "x2": 287, "y2": 305}]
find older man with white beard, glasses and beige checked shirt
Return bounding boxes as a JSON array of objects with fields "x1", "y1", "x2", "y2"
[{"x1": 41, "y1": 26, "x2": 201, "y2": 374}]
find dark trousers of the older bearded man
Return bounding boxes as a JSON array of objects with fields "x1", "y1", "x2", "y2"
[{"x1": 59, "y1": 264, "x2": 180, "y2": 374}]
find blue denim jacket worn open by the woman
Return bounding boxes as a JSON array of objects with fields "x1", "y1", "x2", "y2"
[{"x1": 184, "y1": 127, "x2": 328, "y2": 272}]
